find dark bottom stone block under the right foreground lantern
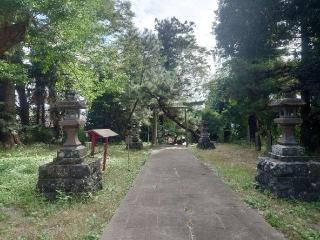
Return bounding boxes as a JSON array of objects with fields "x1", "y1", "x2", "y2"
[{"x1": 256, "y1": 157, "x2": 320, "y2": 201}]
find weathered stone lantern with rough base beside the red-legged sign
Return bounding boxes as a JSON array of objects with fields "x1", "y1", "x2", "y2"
[{"x1": 37, "y1": 92, "x2": 102, "y2": 200}]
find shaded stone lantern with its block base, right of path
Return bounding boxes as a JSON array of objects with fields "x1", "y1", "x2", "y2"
[{"x1": 256, "y1": 97, "x2": 320, "y2": 201}]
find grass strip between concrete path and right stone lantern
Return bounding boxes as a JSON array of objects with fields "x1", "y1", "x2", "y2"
[{"x1": 190, "y1": 144, "x2": 320, "y2": 240}]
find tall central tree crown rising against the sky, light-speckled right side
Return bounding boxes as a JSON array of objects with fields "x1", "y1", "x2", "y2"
[{"x1": 155, "y1": 17, "x2": 209, "y2": 98}]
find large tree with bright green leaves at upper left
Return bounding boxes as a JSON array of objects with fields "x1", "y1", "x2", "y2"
[{"x1": 0, "y1": 0, "x2": 132, "y2": 146}]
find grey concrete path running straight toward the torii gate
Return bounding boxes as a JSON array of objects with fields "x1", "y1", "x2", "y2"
[{"x1": 102, "y1": 147, "x2": 285, "y2": 240}]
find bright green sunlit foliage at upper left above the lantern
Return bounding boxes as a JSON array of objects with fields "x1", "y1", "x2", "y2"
[{"x1": 0, "y1": 0, "x2": 133, "y2": 146}]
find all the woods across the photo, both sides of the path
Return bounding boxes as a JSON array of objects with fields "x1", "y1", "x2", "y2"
[{"x1": 0, "y1": 0, "x2": 320, "y2": 151}]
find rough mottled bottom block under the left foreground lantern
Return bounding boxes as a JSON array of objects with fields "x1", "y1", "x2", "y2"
[{"x1": 37, "y1": 159, "x2": 102, "y2": 200}]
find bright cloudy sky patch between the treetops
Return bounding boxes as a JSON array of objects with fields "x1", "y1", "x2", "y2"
[{"x1": 131, "y1": 0, "x2": 218, "y2": 49}]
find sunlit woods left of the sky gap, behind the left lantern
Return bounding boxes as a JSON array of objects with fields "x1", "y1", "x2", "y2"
[{"x1": 0, "y1": 0, "x2": 209, "y2": 147}]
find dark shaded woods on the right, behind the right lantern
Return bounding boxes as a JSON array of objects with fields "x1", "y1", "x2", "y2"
[{"x1": 207, "y1": 0, "x2": 320, "y2": 150}]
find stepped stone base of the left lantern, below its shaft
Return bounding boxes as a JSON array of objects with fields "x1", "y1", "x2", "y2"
[{"x1": 37, "y1": 146, "x2": 102, "y2": 200}]
